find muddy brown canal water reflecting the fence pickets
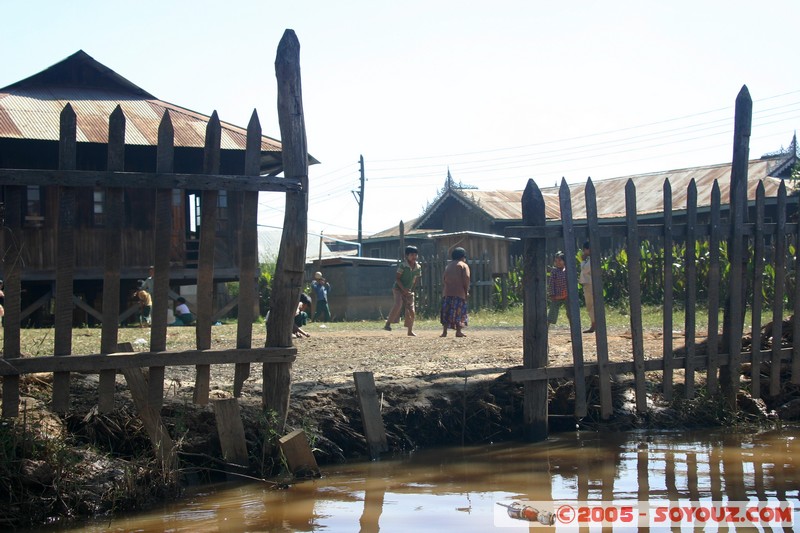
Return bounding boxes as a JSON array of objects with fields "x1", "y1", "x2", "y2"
[{"x1": 39, "y1": 429, "x2": 800, "y2": 533}]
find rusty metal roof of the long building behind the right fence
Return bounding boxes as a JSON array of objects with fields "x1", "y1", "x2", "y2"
[{"x1": 418, "y1": 156, "x2": 800, "y2": 227}]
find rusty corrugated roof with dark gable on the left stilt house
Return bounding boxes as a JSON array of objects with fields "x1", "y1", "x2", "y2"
[{"x1": 0, "y1": 51, "x2": 318, "y2": 171}]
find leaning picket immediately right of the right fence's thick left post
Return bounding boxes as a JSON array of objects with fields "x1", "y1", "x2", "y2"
[{"x1": 558, "y1": 179, "x2": 586, "y2": 418}]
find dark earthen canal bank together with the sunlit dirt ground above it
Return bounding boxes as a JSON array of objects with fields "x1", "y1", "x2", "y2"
[{"x1": 8, "y1": 327, "x2": 800, "y2": 518}]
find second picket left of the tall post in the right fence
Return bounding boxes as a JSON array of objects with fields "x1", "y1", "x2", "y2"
[{"x1": 683, "y1": 178, "x2": 697, "y2": 399}]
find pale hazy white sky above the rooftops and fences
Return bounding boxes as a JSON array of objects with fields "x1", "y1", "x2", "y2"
[{"x1": 0, "y1": 0, "x2": 800, "y2": 235}]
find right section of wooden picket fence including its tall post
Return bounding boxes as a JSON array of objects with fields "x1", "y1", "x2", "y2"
[{"x1": 508, "y1": 88, "x2": 800, "y2": 440}]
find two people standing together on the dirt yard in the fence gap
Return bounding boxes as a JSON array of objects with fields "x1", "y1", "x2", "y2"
[{"x1": 383, "y1": 246, "x2": 470, "y2": 337}]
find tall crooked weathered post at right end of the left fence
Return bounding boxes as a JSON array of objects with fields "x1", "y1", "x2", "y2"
[{"x1": 263, "y1": 30, "x2": 309, "y2": 428}]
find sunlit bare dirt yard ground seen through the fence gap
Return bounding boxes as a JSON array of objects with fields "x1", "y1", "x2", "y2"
[{"x1": 245, "y1": 324, "x2": 668, "y2": 392}]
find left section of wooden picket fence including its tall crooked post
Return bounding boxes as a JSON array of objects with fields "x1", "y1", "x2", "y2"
[{"x1": 0, "y1": 30, "x2": 308, "y2": 466}]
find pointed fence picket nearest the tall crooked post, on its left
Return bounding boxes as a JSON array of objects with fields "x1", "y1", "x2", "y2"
[{"x1": 233, "y1": 110, "x2": 261, "y2": 397}]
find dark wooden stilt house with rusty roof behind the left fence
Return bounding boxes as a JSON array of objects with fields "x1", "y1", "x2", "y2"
[{"x1": 0, "y1": 51, "x2": 317, "y2": 325}]
